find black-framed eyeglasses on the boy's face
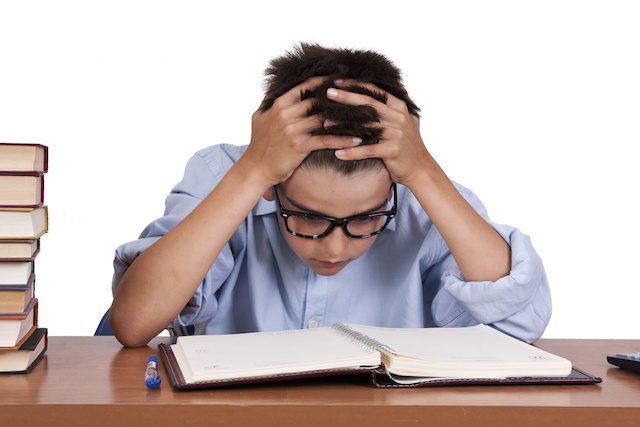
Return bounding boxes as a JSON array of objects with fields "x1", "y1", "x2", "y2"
[{"x1": 273, "y1": 182, "x2": 398, "y2": 239}]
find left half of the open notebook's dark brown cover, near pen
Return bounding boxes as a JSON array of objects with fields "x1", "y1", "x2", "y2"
[{"x1": 158, "y1": 344, "x2": 373, "y2": 390}]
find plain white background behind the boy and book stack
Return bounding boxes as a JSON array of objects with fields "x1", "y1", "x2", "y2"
[{"x1": 0, "y1": 0, "x2": 640, "y2": 340}]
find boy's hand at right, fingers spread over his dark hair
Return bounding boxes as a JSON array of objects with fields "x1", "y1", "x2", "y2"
[{"x1": 327, "y1": 81, "x2": 432, "y2": 187}]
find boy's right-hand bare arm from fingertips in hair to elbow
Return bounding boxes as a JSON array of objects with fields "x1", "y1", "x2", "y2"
[{"x1": 327, "y1": 82, "x2": 511, "y2": 281}]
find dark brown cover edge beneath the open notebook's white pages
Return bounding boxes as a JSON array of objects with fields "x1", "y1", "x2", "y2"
[{"x1": 158, "y1": 344, "x2": 602, "y2": 390}]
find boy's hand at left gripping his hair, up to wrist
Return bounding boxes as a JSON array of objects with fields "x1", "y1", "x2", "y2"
[{"x1": 242, "y1": 77, "x2": 361, "y2": 186}]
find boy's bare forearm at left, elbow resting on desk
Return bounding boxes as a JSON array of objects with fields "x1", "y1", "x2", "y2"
[{"x1": 110, "y1": 162, "x2": 268, "y2": 346}]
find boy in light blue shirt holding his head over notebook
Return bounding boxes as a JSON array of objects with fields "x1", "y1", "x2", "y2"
[{"x1": 110, "y1": 44, "x2": 551, "y2": 346}]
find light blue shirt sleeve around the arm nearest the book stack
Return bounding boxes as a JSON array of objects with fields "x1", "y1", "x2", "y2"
[{"x1": 112, "y1": 150, "x2": 234, "y2": 327}]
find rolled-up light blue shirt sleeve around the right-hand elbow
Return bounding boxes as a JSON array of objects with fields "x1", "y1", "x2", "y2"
[{"x1": 428, "y1": 186, "x2": 551, "y2": 342}]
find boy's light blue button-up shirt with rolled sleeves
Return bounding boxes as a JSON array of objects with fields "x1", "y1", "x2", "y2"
[{"x1": 113, "y1": 145, "x2": 551, "y2": 342}]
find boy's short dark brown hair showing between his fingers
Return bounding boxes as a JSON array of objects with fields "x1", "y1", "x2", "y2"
[{"x1": 260, "y1": 43, "x2": 420, "y2": 175}]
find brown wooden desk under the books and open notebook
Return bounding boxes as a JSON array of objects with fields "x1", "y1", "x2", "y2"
[{"x1": 0, "y1": 337, "x2": 640, "y2": 427}]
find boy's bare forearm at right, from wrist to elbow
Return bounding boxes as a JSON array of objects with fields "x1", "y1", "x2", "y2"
[{"x1": 410, "y1": 158, "x2": 511, "y2": 281}]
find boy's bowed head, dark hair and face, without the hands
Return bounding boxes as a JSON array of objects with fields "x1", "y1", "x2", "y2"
[{"x1": 260, "y1": 43, "x2": 412, "y2": 275}]
